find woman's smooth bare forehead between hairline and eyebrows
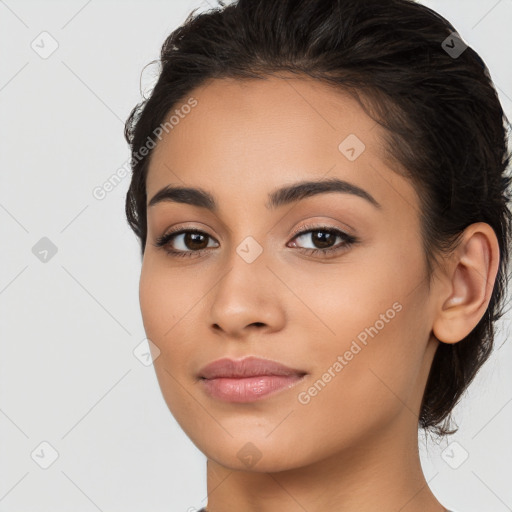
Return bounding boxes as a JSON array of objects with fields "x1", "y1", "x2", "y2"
[{"x1": 146, "y1": 77, "x2": 416, "y2": 213}]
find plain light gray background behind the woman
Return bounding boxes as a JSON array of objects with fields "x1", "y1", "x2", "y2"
[{"x1": 0, "y1": 0, "x2": 512, "y2": 512}]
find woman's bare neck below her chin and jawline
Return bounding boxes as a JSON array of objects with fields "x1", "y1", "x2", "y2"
[{"x1": 203, "y1": 407, "x2": 446, "y2": 512}]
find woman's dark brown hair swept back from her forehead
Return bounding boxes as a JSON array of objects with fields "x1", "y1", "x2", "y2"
[{"x1": 125, "y1": 0, "x2": 511, "y2": 435}]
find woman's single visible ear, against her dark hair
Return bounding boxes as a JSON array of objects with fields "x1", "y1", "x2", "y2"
[{"x1": 432, "y1": 222, "x2": 500, "y2": 343}]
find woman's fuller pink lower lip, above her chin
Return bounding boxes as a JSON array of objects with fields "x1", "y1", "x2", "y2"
[{"x1": 202, "y1": 375, "x2": 303, "y2": 402}]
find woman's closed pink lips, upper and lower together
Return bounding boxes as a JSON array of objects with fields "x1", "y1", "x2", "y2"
[{"x1": 198, "y1": 356, "x2": 307, "y2": 402}]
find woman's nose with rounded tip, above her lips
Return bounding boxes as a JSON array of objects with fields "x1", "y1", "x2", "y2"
[{"x1": 209, "y1": 243, "x2": 286, "y2": 339}]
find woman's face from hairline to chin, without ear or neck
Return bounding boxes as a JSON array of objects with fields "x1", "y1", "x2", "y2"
[{"x1": 140, "y1": 77, "x2": 437, "y2": 471}]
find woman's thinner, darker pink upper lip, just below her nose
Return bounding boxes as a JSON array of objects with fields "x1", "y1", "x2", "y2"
[{"x1": 199, "y1": 356, "x2": 306, "y2": 379}]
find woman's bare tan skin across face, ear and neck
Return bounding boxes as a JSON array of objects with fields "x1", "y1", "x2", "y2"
[{"x1": 140, "y1": 76, "x2": 499, "y2": 512}]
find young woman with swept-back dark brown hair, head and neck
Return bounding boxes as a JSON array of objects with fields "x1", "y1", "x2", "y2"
[{"x1": 122, "y1": 0, "x2": 511, "y2": 512}]
